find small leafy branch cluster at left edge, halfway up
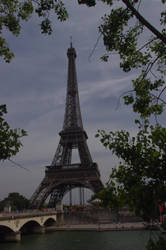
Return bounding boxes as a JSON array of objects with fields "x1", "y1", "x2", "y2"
[{"x1": 0, "y1": 105, "x2": 26, "y2": 161}]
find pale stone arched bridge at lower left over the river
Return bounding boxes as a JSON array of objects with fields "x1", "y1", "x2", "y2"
[{"x1": 0, "y1": 211, "x2": 57, "y2": 241}]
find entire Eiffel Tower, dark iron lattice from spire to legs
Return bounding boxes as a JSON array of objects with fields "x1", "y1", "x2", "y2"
[{"x1": 30, "y1": 43, "x2": 103, "y2": 208}]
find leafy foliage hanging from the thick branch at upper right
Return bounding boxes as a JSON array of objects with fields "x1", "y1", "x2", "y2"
[{"x1": 99, "y1": 0, "x2": 166, "y2": 117}]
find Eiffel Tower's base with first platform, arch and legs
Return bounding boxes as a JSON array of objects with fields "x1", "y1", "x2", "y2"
[{"x1": 31, "y1": 163, "x2": 103, "y2": 208}]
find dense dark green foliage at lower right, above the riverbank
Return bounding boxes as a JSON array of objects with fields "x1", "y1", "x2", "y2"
[{"x1": 96, "y1": 121, "x2": 166, "y2": 221}]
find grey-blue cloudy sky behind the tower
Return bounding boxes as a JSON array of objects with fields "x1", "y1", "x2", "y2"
[{"x1": 0, "y1": 0, "x2": 160, "y2": 203}]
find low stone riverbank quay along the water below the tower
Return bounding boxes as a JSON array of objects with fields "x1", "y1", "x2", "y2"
[{"x1": 49, "y1": 222, "x2": 147, "y2": 232}]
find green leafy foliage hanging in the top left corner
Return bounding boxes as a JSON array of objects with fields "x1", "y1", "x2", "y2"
[{"x1": 0, "y1": 0, "x2": 68, "y2": 63}]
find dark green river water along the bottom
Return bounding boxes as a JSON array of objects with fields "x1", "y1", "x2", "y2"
[{"x1": 0, "y1": 231, "x2": 158, "y2": 250}]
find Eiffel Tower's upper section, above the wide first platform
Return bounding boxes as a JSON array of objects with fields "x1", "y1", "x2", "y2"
[{"x1": 51, "y1": 43, "x2": 93, "y2": 167}]
